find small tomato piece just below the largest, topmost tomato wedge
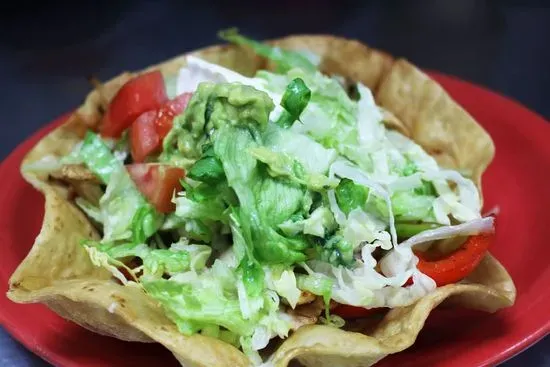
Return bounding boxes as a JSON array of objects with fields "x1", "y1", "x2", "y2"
[{"x1": 130, "y1": 111, "x2": 160, "y2": 163}]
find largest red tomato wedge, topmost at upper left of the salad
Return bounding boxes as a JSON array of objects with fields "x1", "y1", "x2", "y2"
[{"x1": 99, "y1": 71, "x2": 168, "y2": 138}]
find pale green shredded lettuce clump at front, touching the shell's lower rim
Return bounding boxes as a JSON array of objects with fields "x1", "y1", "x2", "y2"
[{"x1": 142, "y1": 260, "x2": 296, "y2": 362}]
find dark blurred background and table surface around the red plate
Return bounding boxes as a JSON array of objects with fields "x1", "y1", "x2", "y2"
[{"x1": 0, "y1": 0, "x2": 550, "y2": 367}]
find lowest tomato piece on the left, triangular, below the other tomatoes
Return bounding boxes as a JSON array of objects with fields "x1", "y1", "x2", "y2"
[{"x1": 127, "y1": 164, "x2": 185, "y2": 213}]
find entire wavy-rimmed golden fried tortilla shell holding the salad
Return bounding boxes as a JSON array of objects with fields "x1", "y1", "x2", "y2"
[{"x1": 8, "y1": 35, "x2": 516, "y2": 366}]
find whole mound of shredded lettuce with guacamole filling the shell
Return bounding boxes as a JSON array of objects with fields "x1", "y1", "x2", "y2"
[{"x1": 66, "y1": 30, "x2": 488, "y2": 364}]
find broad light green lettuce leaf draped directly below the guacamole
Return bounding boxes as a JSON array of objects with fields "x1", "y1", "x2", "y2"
[{"x1": 214, "y1": 126, "x2": 307, "y2": 264}]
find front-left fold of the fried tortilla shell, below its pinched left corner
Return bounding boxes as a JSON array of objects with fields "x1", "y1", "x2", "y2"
[{"x1": 8, "y1": 186, "x2": 253, "y2": 366}]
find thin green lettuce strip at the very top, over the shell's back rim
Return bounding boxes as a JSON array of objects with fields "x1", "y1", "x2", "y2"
[{"x1": 218, "y1": 28, "x2": 317, "y2": 73}]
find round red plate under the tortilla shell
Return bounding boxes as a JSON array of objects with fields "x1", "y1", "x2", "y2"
[{"x1": 0, "y1": 73, "x2": 550, "y2": 367}]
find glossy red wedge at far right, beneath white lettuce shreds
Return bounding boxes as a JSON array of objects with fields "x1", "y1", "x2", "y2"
[{"x1": 415, "y1": 234, "x2": 494, "y2": 287}]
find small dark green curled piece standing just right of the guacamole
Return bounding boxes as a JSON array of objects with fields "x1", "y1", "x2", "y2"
[{"x1": 277, "y1": 78, "x2": 311, "y2": 129}]
